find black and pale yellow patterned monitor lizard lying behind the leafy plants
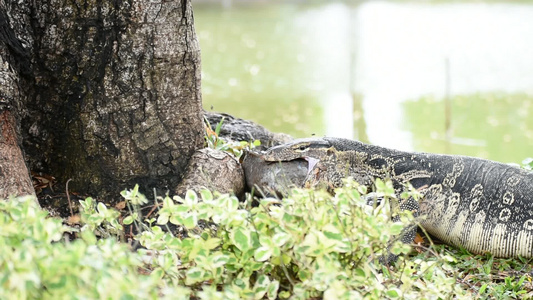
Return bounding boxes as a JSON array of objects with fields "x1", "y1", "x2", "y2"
[{"x1": 263, "y1": 138, "x2": 533, "y2": 258}]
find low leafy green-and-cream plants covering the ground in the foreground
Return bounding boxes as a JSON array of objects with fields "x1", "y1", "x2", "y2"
[{"x1": 0, "y1": 180, "x2": 531, "y2": 299}]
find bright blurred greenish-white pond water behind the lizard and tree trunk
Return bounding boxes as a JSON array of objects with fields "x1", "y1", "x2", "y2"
[{"x1": 194, "y1": 1, "x2": 533, "y2": 162}]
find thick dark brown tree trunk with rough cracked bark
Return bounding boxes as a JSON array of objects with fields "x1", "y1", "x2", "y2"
[{"x1": 0, "y1": 0, "x2": 204, "y2": 200}]
